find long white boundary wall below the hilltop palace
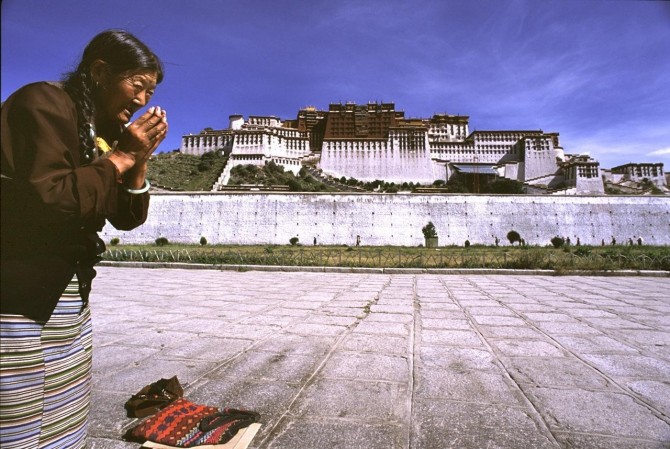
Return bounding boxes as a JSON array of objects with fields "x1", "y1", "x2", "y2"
[{"x1": 101, "y1": 192, "x2": 670, "y2": 246}]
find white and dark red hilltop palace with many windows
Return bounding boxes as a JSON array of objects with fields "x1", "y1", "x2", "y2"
[{"x1": 180, "y1": 102, "x2": 668, "y2": 195}]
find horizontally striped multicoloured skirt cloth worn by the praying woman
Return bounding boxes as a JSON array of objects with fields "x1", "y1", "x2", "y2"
[{"x1": 0, "y1": 276, "x2": 93, "y2": 449}]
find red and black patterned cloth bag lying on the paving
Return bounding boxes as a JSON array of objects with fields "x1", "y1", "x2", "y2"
[{"x1": 127, "y1": 398, "x2": 260, "y2": 447}]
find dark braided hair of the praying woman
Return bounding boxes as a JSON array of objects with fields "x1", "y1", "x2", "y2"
[{"x1": 63, "y1": 30, "x2": 163, "y2": 164}]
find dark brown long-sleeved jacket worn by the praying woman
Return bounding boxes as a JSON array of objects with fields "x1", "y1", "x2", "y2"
[{"x1": 0, "y1": 83, "x2": 149, "y2": 321}]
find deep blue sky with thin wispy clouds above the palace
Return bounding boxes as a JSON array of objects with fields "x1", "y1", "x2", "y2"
[{"x1": 1, "y1": 0, "x2": 670, "y2": 170}]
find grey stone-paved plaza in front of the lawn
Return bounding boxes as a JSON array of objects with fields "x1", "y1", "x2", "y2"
[{"x1": 90, "y1": 267, "x2": 670, "y2": 449}]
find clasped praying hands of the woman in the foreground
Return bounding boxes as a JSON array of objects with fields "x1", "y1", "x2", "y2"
[{"x1": 109, "y1": 106, "x2": 168, "y2": 174}]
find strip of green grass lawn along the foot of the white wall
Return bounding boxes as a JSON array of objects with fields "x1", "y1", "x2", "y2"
[{"x1": 103, "y1": 244, "x2": 670, "y2": 271}]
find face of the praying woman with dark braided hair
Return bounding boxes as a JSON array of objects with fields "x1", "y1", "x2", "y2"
[{"x1": 96, "y1": 70, "x2": 157, "y2": 125}]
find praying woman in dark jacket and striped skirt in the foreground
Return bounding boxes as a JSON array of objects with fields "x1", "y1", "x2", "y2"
[{"x1": 0, "y1": 30, "x2": 168, "y2": 449}]
